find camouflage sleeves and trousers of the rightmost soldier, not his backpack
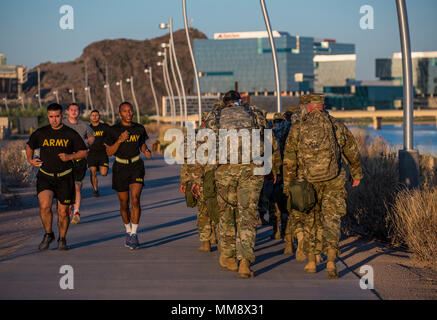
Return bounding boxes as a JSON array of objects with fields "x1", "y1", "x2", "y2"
[{"x1": 283, "y1": 94, "x2": 363, "y2": 254}]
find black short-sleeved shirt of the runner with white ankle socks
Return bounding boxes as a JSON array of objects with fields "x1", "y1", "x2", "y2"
[{"x1": 105, "y1": 122, "x2": 149, "y2": 159}]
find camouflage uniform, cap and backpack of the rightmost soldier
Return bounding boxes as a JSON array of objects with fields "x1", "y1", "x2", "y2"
[{"x1": 283, "y1": 94, "x2": 363, "y2": 275}]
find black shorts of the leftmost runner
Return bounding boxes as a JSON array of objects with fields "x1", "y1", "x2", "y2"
[{"x1": 36, "y1": 171, "x2": 76, "y2": 205}]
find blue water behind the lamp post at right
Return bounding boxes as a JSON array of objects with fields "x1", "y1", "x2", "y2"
[{"x1": 350, "y1": 124, "x2": 437, "y2": 156}]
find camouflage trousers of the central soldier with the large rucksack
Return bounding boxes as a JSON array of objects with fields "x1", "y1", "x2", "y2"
[{"x1": 215, "y1": 164, "x2": 264, "y2": 262}]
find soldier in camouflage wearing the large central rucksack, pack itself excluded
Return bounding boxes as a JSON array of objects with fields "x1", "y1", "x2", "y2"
[{"x1": 200, "y1": 91, "x2": 266, "y2": 278}]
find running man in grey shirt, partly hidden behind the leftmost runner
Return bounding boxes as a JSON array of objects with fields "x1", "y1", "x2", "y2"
[{"x1": 64, "y1": 103, "x2": 94, "y2": 224}]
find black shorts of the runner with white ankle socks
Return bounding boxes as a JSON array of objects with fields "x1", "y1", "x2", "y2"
[{"x1": 112, "y1": 159, "x2": 145, "y2": 192}]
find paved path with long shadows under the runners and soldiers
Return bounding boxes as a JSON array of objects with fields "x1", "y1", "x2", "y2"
[{"x1": 0, "y1": 157, "x2": 377, "y2": 300}]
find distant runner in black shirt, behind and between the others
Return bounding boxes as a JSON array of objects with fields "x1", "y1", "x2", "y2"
[{"x1": 87, "y1": 110, "x2": 110, "y2": 197}]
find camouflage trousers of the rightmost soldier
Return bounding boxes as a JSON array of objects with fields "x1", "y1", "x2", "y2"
[{"x1": 304, "y1": 170, "x2": 347, "y2": 254}]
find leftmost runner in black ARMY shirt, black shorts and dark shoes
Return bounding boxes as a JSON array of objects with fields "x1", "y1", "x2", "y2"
[{"x1": 26, "y1": 103, "x2": 87, "y2": 251}]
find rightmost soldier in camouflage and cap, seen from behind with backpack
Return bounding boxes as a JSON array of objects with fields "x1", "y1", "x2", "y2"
[{"x1": 283, "y1": 94, "x2": 363, "y2": 278}]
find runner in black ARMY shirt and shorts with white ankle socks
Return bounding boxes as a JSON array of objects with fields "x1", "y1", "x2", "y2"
[{"x1": 105, "y1": 102, "x2": 152, "y2": 249}]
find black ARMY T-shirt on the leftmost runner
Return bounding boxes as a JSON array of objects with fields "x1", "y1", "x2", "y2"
[{"x1": 27, "y1": 125, "x2": 87, "y2": 173}]
